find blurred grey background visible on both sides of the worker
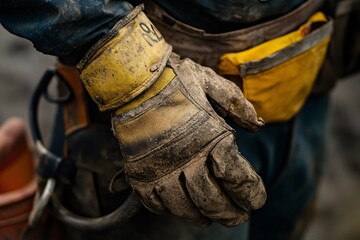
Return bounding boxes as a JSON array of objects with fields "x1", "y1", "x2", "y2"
[{"x1": 0, "y1": 26, "x2": 360, "y2": 240}]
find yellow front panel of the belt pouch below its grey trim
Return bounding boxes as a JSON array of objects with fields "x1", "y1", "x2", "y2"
[{"x1": 243, "y1": 39, "x2": 330, "y2": 123}]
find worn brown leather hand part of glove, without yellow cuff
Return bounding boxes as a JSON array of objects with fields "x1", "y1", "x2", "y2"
[{"x1": 112, "y1": 54, "x2": 266, "y2": 226}]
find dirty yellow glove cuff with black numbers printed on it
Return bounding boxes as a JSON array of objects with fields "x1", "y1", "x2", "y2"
[{"x1": 80, "y1": 12, "x2": 171, "y2": 111}]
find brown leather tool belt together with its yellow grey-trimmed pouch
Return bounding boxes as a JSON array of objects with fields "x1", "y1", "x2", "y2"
[{"x1": 146, "y1": 0, "x2": 333, "y2": 123}]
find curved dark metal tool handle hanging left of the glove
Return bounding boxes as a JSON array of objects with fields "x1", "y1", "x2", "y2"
[{"x1": 29, "y1": 69, "x2": 142, "y2": 231}]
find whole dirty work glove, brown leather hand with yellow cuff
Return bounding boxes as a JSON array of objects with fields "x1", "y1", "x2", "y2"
[{"x1": 78, "y1": 7, "x2": 266, "y2": 226}]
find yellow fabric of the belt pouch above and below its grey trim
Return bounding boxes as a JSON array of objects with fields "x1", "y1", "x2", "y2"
[{"x1": 219, "y1": 13, "x2": 330, "y2": 123}]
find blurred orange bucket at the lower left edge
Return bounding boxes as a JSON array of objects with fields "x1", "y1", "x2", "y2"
[{"x1": 0, "y1": 118, "x2": 36, "y2": 240}]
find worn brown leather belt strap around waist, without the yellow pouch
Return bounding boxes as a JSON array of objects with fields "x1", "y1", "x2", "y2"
[{"x1": 145, "y1": 0, "x2": 324, "y2": 69}]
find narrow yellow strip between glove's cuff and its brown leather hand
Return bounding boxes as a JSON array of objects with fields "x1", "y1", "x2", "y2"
[{"x1": 115, "y1": 67, "x2": 176, "y2": 114}]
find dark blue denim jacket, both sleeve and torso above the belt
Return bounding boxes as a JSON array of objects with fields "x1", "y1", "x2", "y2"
[{"x1": 0, "y1": 0, "x2": 305, "y2": 57}]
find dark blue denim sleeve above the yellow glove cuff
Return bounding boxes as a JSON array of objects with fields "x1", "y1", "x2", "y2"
[{"x1": 0, "y1": 0, "x2": 132, "y2": 57}]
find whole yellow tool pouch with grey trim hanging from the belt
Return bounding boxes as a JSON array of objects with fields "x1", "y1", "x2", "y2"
[{"x1": 218, "y1": 12, "x2": 333, "y2": 122}]
